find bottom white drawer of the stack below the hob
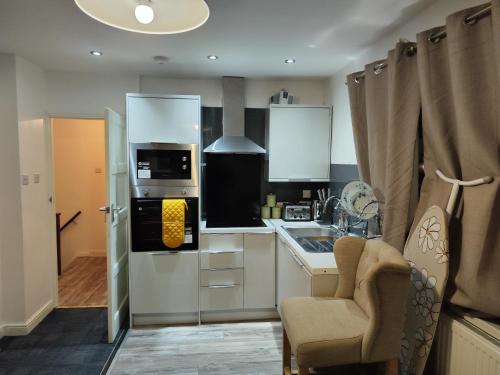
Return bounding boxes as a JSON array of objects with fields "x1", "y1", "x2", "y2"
[{"x1": 200, "y1": 284, "x2": 243, "y2": 311}]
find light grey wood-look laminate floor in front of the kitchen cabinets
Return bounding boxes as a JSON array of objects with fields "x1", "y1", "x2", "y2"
[{"x1": 108, "y1": 322, "x2": 376, "y2": 375}]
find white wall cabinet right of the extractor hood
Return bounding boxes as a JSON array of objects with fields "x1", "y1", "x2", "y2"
[{"x1": 267, "y1": 105, "x2": 332, "y2": 182}]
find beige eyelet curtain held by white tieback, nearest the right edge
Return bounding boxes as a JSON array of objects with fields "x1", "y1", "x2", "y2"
[{"x1": 416, "y1": 0, "x2": 500, "y2": 316}]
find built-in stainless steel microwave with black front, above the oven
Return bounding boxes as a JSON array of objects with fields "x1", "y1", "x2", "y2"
[{"x1": 129, "y1": 143, "x2": 198, "y2": 187}]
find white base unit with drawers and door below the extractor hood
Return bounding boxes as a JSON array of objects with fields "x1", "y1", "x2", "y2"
[{"x1": 200, "y1": 233, "x2": 276, "y2": 313}]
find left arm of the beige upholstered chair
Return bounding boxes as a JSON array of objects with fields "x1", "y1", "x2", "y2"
[{"x1": 333, "y1": 237, "x2": 366, "y2": 299}]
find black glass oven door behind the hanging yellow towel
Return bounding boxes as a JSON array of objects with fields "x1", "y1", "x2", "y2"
[{"x1": 130, "y1": 198, "x2": 199, "y2": 252}]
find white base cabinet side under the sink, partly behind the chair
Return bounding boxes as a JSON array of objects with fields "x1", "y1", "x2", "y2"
[{"x1": 276, "y1": 236, "x2": 312, "y2": 312}]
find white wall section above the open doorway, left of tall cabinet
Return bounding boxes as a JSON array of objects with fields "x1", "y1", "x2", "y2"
[{"x1": 46, "y1": 71, "x2": 139, "y2": 118}]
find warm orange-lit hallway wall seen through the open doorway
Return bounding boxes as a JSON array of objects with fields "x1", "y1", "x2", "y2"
[{"x1": 52, "y1": 119, "x2": 106, "y2": 271}]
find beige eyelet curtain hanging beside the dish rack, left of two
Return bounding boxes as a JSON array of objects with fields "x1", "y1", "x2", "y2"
[{"x1": 347, "y1": 43, "x2": 420, "y2": 252}]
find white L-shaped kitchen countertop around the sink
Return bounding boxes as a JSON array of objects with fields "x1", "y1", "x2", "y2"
[{"x1": 266, "y1": 219, "x2": 338, "y2": 275}]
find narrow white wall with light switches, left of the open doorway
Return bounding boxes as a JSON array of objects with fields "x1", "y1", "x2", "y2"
[{"x1": 16, "y1": 57, "x2": 56, "y2": 320}]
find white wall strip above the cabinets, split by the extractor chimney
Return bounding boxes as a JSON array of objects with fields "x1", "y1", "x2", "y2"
[{"x1": 141, "y1": 76, "x2": 327, "y2": 108}]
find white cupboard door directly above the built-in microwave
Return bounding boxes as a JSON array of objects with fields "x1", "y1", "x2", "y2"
[{"x1": 127, "y1": 94, "x2": 201, "y2": 144}]
